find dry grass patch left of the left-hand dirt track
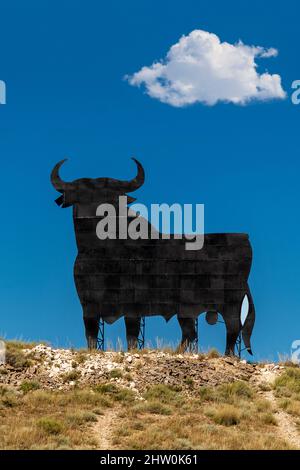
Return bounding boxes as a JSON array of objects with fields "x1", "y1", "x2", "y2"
[{"x1": 0, "y1": 387, "x2": 112, "y2": 449}]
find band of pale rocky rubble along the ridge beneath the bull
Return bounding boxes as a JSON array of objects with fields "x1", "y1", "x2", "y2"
[{"x1": 0, "y1": 345, "x2": 278, "y2": 397}]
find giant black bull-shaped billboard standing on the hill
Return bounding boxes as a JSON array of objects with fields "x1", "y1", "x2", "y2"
[{"x1": 51, "y1": 159, "x2": 255, "y2": 355}]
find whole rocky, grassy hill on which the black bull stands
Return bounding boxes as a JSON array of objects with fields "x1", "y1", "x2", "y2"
[{"x1": 0, "y1": 342, "x2": 300, "y2": 449}]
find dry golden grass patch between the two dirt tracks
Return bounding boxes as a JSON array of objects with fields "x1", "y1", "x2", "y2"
[{"x1": 113, "y1": 382, "x2": 289, "y2": 450}]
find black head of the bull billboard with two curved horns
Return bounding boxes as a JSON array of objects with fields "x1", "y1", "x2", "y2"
[{"x1": 51, "y1": 158, "x2": 145, "y2": 208}]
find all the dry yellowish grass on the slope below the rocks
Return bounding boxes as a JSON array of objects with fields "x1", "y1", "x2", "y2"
[{"x1": 0, "y1": 375, "x2": 295, "y2": 450}]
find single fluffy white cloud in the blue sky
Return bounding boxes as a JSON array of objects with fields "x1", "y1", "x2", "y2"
[{"x1": 125, "y1": 29, "x2": 286, "y2": 107}]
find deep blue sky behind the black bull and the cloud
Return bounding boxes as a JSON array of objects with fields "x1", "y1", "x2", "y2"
[{"x1": 0, "y1": 0, "x2": 300, "y2": 359}]
